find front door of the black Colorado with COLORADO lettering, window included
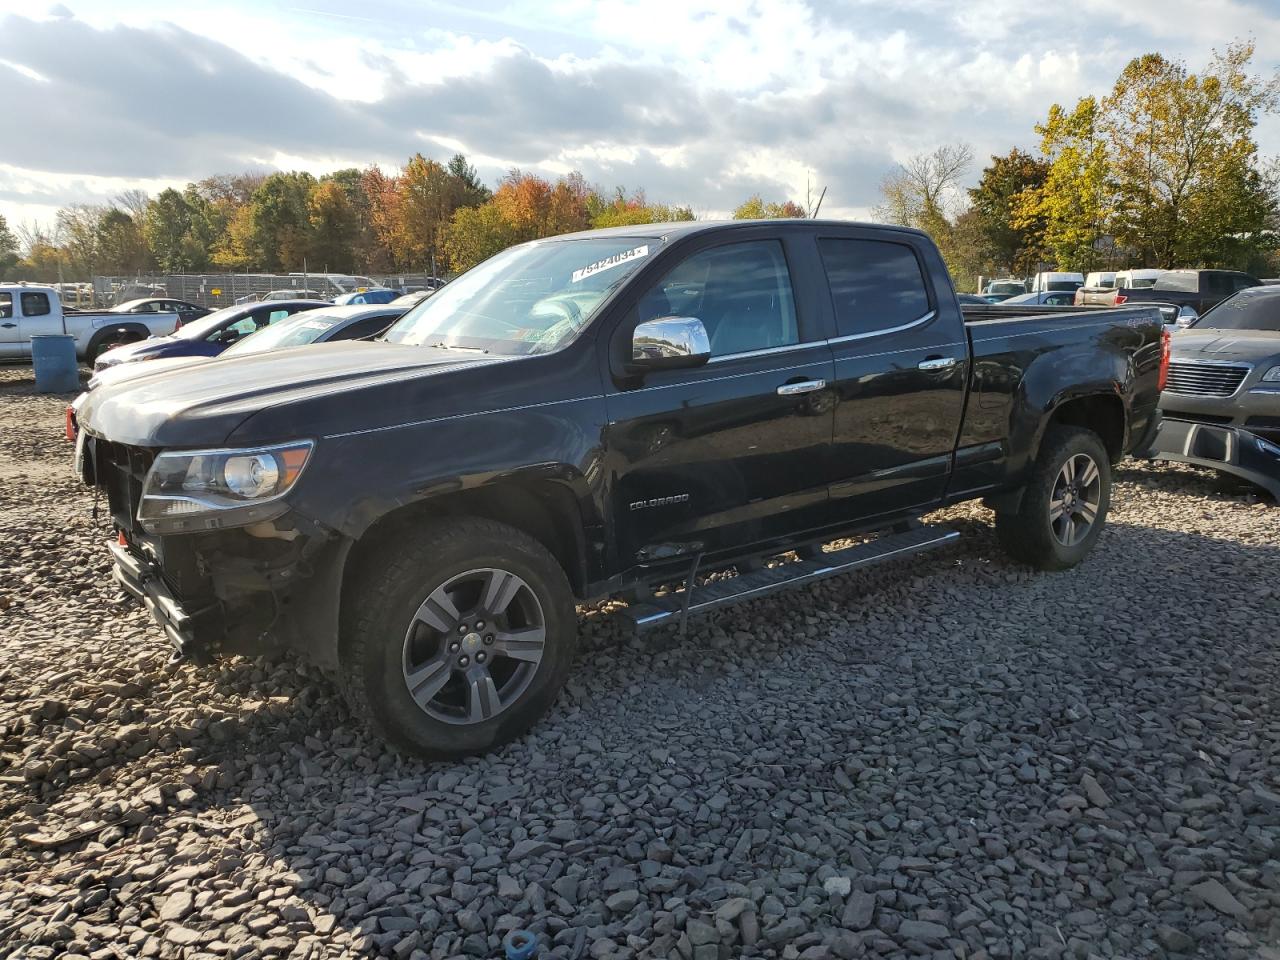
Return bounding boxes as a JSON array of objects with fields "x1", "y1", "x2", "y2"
[{"x1": 605, "y1": 238, "x2": 833, "y2": 568}]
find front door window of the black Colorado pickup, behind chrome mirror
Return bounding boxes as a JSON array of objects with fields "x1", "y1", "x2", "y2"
[{"x1": 640, "y1": 241, "x2": 800, "y2": 357}]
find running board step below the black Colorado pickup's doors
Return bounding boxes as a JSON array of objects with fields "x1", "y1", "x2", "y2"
[{"x1": 625, "y1": 526, "x2": 960, "y2": 630}]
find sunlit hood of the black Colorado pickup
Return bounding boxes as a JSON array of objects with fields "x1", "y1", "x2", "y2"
[{"x1": 77, "y1": 340, "x2": 516, "y2": 448}]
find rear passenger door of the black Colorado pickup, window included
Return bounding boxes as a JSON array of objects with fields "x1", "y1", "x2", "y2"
[{"x1": 818, "y1": 230, "x2": 962, "y2": 520}]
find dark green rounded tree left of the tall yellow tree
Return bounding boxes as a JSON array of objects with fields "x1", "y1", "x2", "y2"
[{"x1": 969, "y1": 147, "x2": 1048, "y2": 276}]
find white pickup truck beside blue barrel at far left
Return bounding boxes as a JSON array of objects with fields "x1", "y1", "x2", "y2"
[{"x1": 0, "y1": 283, "x2": 178, "y2": 364}]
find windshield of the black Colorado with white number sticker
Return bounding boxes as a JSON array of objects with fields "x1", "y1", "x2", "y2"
[{"x1": 383, "y1": 237, "x2": 662, "y2": 356}]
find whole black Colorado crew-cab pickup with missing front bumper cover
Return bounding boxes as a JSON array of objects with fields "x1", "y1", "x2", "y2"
[{"x1": 77, "y1": 220, "x2": 1169, "y2": 756}]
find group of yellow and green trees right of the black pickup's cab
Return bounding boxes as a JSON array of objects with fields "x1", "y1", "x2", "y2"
[{"x1": 877, "y1": 42, "x2": 1280, "y2": 289}]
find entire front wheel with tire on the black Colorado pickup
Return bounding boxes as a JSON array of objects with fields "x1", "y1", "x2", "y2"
[{"x1": 340, "y1": 518, "x2": 577, "y2": 759}]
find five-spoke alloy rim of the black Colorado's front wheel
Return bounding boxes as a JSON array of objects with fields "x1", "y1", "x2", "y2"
[{"x1": 401, "y1": 567, "x2": 547, "y2": 724}]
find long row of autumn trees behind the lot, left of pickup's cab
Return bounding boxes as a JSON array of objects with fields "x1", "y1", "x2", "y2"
[{"x1": 0, "y1": 154, "x2": 805, "y2": 282}]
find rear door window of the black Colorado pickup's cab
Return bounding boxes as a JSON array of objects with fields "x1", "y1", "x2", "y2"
[{"x1": 818, "y1": 238, "x2": 929, "y2": 337}]
